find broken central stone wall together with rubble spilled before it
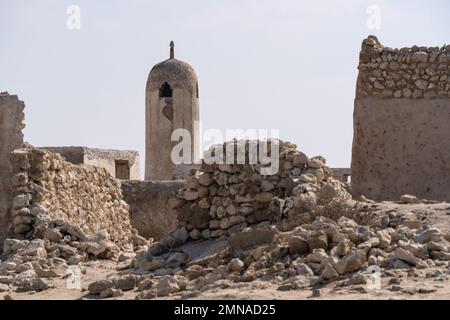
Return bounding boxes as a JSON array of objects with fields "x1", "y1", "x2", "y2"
[{"x1": 78, "y1": 143, "x2": 450, "y2": 299}]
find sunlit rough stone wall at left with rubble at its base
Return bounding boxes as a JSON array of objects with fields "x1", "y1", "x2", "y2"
[{"x1": 0, "y1": 147, "x2": 148, "y2": 291}]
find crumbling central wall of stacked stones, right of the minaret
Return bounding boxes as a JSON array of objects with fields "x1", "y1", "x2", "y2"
[{"x1": 172, "y1": 141, "x2": 349, "y2": 240}]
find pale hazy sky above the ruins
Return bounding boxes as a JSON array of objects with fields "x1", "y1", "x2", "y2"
[{"x1": 0, "y1": 0, "x2": 450, "y2": 176}]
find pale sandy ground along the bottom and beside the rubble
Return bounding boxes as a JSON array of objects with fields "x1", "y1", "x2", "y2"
[{"x1": 5, "y1": 202, "x2": 450, "y2": 300}]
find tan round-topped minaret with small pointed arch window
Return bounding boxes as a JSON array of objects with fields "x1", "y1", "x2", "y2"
[{"x1": 145, "y1": 42, "x2": 199, "y2": 180}]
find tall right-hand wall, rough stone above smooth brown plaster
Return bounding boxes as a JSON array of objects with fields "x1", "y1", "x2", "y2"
[{"x1": 351, "y1": 36, "x2": 450, "y2": 201}]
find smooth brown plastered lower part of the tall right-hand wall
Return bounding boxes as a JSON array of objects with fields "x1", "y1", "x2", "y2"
[{"x1": 352, "y1": 97, "x2": 450, "y2": 201}]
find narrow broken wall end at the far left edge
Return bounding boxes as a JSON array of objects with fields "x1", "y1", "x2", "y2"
[{"x1": 0, "y1": 92, "x2": 25, "y2": 247}]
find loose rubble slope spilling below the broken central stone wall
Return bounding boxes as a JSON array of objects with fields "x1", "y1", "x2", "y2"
[{"x1": 118, "y1": 206, "x2": 450, "y2": 299}]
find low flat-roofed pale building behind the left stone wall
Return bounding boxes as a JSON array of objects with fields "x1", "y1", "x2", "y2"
[{"x1": 42, "y1": 147, "x2": 140, "y2": 180}]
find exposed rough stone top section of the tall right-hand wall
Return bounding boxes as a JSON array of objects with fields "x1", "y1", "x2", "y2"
[{"x1": 356, "y1": 36, "x2": 450, "y2": 99}]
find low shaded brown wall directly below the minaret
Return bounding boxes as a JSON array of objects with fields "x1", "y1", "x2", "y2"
[{"x1": 122, "y1": 180, "x2": 184, "y2": 240}]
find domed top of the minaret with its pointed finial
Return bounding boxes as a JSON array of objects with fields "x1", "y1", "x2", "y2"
[{"x1": 147, "y1": 41, "x2": 197, "y2": 90}]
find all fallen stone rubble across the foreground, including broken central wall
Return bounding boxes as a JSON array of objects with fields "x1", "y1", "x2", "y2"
[{"x1": 0, "y1": 142, "x2": 450, "y2": 299}]
